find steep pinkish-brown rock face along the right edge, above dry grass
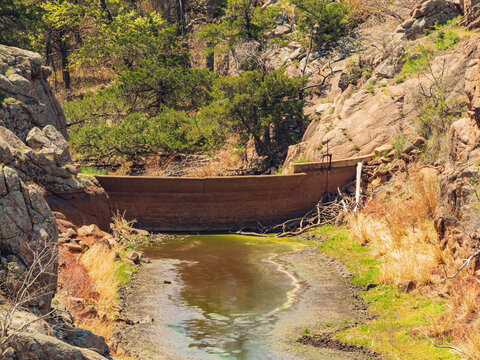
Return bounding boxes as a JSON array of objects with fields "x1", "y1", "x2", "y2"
[{"x1": 435, "y1": 45, "x2": 480, "y2": 258}]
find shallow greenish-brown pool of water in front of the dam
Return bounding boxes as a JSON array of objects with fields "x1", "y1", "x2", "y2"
[{"x1": 142, "y1": 235, "x2": 297, "y2": 359}]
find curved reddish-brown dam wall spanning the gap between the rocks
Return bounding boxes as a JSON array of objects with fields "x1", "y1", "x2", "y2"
[{"x1": 97, "y1": 159, "x2": 372, "y2": 232}]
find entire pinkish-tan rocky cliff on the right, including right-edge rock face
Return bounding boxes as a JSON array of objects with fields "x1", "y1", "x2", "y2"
[{"x1": 278, "y1": 0, "x2": 480, "y2": 262}]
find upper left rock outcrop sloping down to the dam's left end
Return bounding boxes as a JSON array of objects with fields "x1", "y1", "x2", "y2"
[{"x1": 0, "y1": 45, "x2": 111, "y2": 230}]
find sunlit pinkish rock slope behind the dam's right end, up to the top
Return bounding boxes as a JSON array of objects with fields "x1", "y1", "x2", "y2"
[{"x1": 285, "y1": 0, "x2": 480, "y2": 165}]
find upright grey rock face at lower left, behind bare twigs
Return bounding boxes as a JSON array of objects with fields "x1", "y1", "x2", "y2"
[{"x1": 0, "y1": 166, "x2": 58, "y2": 313}]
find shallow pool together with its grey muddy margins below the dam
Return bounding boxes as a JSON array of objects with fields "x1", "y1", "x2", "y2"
[{"x1": 126, "y1": 235, "x2": 356, "y2": 360}]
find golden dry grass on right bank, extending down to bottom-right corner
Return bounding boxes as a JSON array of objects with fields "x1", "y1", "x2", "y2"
[{"x1": 349, "y1": 167, "x2": 480, "y2": 352}]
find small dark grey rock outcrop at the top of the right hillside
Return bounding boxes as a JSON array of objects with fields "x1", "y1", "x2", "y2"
[{"x1": 394, "y1": 0, "x2": 460, "y2": 40}]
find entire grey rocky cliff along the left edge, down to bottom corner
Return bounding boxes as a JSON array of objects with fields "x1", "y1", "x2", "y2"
[{"x1": 0, "y1": 45, "x2": 111, "y2": 359}]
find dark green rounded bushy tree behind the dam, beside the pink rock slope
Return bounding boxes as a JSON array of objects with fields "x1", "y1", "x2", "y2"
[{"x1": 209, "y1": 69, "x2": 305, "y2": 162}]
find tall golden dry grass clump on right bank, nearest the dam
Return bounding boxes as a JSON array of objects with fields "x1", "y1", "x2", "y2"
[{"x1": 349, "y1": 176, "x2": 444, "y2": 284}]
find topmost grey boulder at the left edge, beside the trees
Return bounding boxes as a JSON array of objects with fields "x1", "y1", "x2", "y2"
[{"x1": 0, "y1": 45, "x2": 67, "y2": 141}]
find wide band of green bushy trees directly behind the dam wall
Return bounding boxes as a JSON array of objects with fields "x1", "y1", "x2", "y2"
[{"x1": 65, "y1": 68, "x2": 305, "y2": 165}]
